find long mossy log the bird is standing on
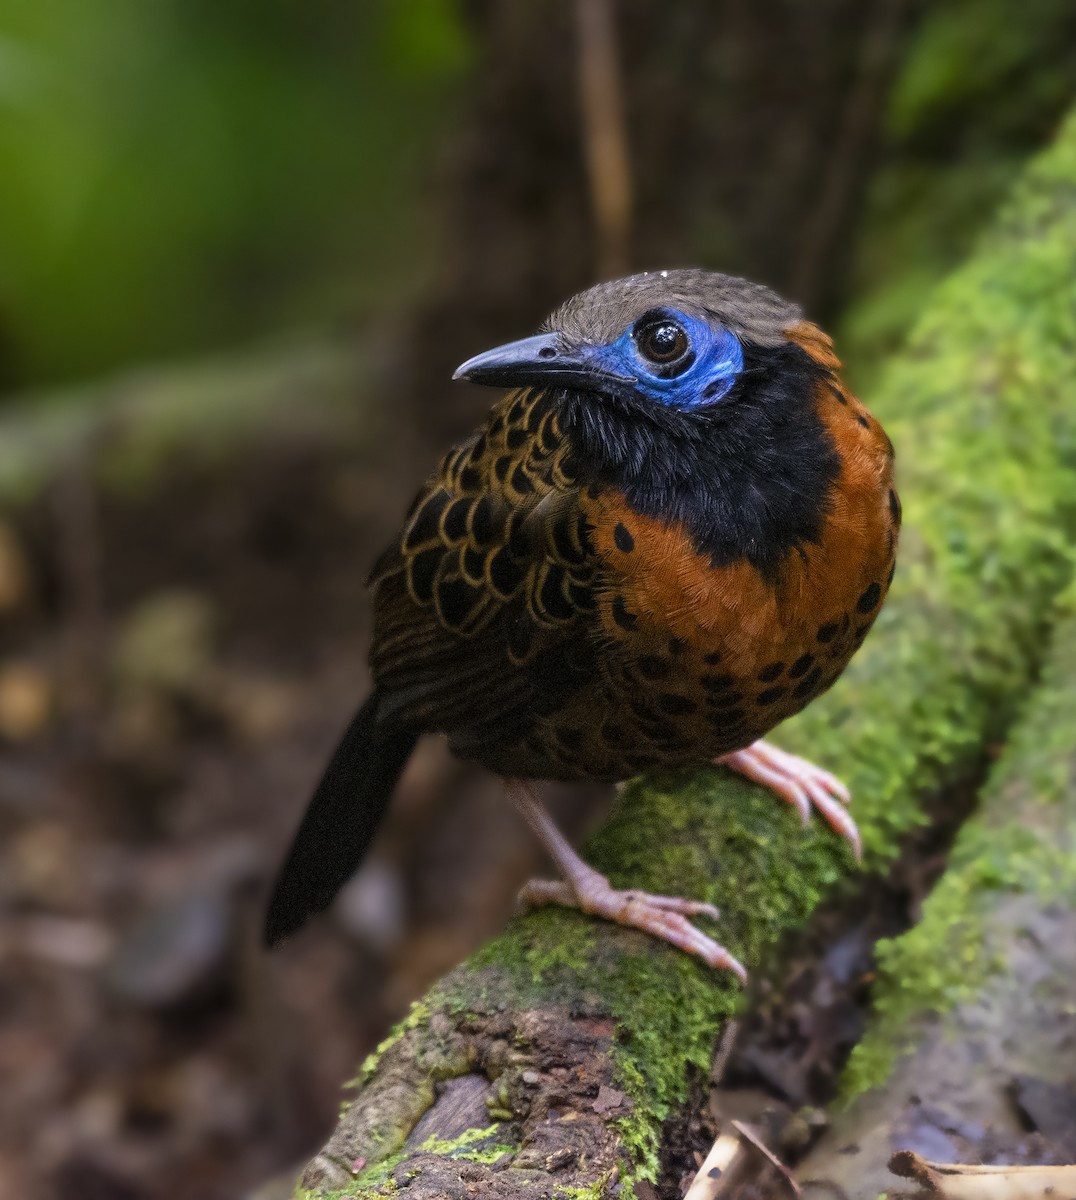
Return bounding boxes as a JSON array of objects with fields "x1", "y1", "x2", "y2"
[{"x1": 291, "y1": 120, "x2": 1076, "y2": 1200}]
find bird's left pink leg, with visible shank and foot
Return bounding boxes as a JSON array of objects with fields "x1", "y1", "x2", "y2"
[{"x1": 506, "y1": 780, "x2": 747, "y2": 980}]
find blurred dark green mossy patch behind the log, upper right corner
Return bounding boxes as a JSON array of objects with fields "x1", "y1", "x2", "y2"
[{"x1": 838, "y1": 0, "x2": 1076, "y2": 385}]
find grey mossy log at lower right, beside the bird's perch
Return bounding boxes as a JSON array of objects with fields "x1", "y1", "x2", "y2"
[{"x1": 797, "y1": 587, "x2": 1076, "y2": 1196}]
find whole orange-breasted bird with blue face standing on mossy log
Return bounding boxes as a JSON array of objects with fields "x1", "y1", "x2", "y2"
[{"x1": 265, "y1": 268, "x2": 901, "y2": 979}]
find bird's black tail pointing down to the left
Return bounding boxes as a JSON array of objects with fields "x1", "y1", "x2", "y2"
[{"x1": 265, "y1": 692, "x2": 419, "y2": 946}]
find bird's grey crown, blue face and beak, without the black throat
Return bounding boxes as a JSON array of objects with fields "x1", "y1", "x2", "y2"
[{"x1": 453, "y1": 270, "x2": 803, "y2": 416}]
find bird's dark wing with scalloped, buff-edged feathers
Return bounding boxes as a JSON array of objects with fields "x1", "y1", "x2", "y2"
[{"x1": 371, "y1": 390, "x2": 599, "y2": 743}]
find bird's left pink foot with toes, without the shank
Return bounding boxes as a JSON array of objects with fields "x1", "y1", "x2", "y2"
[{"x1": 519, "y1": 869, "x2": 747, "y2": 983}]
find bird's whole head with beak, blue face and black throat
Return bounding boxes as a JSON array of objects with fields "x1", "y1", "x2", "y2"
[{"x1": 456, "y1": 270, "x2": 840, "y2": 570}]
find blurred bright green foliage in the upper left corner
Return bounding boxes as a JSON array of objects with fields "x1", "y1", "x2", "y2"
[{"x1": 0, "y1": 0, "x2": 473, "y2": 388}]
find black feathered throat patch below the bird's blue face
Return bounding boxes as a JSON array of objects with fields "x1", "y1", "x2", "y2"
[{"x1": 555, "y1": 343, "x2": 841, "y2": 580}]
